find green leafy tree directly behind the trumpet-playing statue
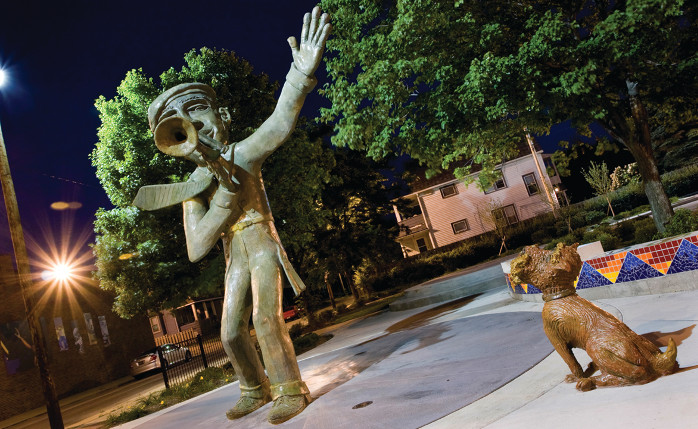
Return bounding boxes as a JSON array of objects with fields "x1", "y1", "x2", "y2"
[{"x1": 91, "y1": 48, "x2": 331, "y2": 317}]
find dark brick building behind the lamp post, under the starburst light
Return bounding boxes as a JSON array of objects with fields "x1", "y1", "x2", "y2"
[{"x1": 0, "y1": 255, "x2": 155, "y2": 420}]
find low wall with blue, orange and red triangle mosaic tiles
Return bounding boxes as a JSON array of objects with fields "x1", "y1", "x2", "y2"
[{"x1": 507, "y1": 232, "x2": 698, "y2": 294}]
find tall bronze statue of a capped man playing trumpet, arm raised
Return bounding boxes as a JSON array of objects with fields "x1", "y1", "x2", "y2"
[{"x1": 134, "y1": 7, "x2": 330, "y2": 424}]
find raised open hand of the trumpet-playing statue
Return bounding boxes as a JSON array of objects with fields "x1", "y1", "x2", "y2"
[{"x1": 288, "y1": 6, "x2": 332, "y2": 76}]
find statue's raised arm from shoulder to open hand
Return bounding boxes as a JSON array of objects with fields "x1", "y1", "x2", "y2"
[{"x1": 235, "y1": 7, "x2": 331, "y2": 162}]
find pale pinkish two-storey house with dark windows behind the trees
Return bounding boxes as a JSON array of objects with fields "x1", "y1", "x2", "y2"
[{"x1": 395, "y1": 150, "x2": 560, "y2": 257}]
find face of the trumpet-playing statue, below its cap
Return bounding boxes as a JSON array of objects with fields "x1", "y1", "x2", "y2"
[{"x1": 159, "y1": 94, "x2": 229, "y2": 144}]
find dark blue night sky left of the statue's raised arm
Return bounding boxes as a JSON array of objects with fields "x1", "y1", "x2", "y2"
[{"x1": 0, "y1": 0, "x2": 327, "y2": 258}]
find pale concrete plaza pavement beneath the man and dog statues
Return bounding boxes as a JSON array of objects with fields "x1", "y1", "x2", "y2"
[{"x1": 115, "y1": 290, "x2": 698, "y2": 429}]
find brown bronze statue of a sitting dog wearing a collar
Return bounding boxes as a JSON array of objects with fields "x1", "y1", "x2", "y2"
[{"x1": 510, "y1": 243, "x2": 678, "y2": 391}]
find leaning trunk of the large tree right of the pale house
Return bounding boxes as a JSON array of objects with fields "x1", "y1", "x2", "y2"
[{"x1": 624, "y1": 81, "x2": 674, "y2": 233}]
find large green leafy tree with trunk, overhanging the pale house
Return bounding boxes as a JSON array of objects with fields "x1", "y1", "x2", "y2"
[{"x1": 322, "y1": 0, "x2": 698, "y2": 231}]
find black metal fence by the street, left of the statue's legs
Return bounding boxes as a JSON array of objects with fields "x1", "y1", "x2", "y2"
[{"x1": 158, "y1": 329, "x2": 228, "y2": 389}]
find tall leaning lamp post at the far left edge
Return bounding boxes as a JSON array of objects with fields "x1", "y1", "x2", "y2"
[{"x1": 0, "y1": 69, "x2": 63, "y2": 429}]
